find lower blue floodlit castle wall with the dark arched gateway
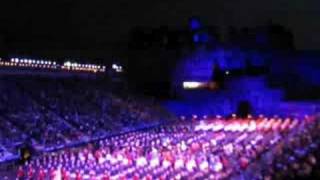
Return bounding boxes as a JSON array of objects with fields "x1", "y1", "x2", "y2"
[{"x1": 165, "y1": 76, "x2": 320, "y2": 117}]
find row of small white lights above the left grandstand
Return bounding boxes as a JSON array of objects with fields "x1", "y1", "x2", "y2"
[{"x1": 0, "y1": 58, "x2": 111, "y2": 73}]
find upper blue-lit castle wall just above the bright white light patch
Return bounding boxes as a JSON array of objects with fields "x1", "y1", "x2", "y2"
[{"x1": 173, "y1": 48, "x2": 267, "y2": 88}]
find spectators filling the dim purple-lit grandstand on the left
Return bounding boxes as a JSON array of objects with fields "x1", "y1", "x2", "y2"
[{"x1": 0, "y1": 77, "x2": 172, "y2": 162}]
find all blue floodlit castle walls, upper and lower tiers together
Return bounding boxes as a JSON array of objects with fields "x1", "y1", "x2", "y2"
[{"x1": 165, "y1": 49, "x2": 320, "y2": 116}]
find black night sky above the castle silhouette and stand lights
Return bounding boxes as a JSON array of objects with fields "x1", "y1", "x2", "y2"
[{"x1": 0, "y1": 0, "x2": 320, "y2": 49}]
